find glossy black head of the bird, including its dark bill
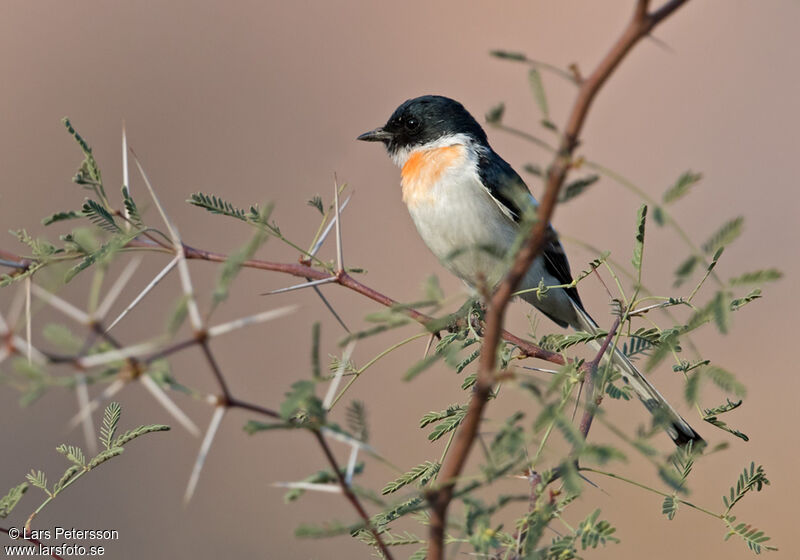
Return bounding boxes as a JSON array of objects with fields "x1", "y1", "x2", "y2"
[{"x1": 357, "y1": 95, "x2": 487, "y2": 155}]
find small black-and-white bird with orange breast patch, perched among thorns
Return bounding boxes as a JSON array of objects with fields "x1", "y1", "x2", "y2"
[{"x1": 357, "y1": 95, "x2": 705, "y2": 447}]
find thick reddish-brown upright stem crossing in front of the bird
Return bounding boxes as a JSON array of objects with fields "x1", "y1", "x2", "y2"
[{"x1": 426, "y1": 0, "x2": 686, "y2": 560}]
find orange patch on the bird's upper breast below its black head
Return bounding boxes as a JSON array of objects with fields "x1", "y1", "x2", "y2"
[{"x1": 400, "y1": 144, "x2": 466, "y2": 206}]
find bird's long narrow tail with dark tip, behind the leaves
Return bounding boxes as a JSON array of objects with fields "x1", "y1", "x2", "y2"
[{"x1": 573, "y1": 302, "x2": 705, "y2": 449}]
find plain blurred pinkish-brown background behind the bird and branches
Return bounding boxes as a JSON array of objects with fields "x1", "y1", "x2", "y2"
[{"x1": 0, "y1": 0, "x2": 800, "y2": 559}]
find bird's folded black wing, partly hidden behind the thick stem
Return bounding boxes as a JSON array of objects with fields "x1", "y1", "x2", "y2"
[{"x1": 478, "y1": 148, "x2": 583, "y2": 309}]
